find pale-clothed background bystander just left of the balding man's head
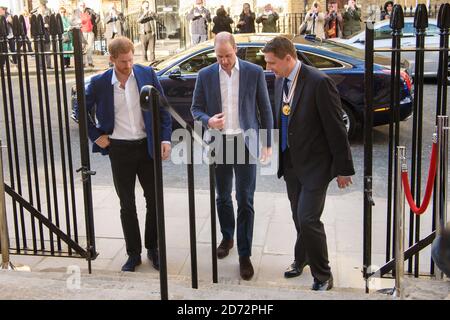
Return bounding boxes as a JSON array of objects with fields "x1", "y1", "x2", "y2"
[{"x1": 186, "y1": 0, "x2": 211, "y2": 45}]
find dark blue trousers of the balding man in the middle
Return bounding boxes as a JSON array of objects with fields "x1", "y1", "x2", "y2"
[{"x1": 215, "y1": 136, "x2": 256, "y2": 257}]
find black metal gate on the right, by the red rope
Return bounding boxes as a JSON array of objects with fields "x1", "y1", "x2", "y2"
[{"x1": 363, "y1": 3, "x2": 450, "y2": 292}]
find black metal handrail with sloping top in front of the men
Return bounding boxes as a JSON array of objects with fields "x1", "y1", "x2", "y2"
[{"x1": 140, "y1": 86, "x2": 218, "y2": 300}]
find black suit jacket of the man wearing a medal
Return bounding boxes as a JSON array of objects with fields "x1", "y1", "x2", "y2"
[{"x1": 274, "y1": 63, "x2": 355, "y2": 189}]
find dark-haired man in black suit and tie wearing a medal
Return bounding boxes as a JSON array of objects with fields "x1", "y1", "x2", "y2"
[{"x1": 263, "y1": 36, "x2": 355, "y2": 291}]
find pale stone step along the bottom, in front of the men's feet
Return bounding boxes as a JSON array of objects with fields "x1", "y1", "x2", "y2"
[{"x1": 0, "y1": 269, "x2": 392, "y2": 300}]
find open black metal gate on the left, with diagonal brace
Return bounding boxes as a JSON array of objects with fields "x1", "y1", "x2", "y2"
[{"x1": 0, "y1": 14, "x2": 97, "y2": 272}]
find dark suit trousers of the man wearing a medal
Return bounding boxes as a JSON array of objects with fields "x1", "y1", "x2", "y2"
[{"x1": 283, "y1": 149, "x2": 331, "y2": 282}]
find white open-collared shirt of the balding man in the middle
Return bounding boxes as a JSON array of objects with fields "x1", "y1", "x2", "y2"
[{"x1": 219, "y1": 59, "x2": 242, "y2": 134}]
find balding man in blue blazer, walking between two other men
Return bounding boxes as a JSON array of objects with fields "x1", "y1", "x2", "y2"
[{"x1": 191, "y1": 32, "x2": 273, "y2": 280}]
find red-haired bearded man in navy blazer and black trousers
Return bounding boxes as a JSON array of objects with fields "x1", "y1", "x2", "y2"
[{"x1": 86, "y1": 37, "x2": 172, "y2": 271}]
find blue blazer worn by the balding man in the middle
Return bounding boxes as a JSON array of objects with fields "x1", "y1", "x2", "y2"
[{"x1": 191, "y1": 59, "x2": 273, "y2": 158}]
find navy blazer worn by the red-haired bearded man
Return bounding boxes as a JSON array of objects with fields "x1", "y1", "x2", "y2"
[{"x1": 86, "y1": 65, "x2": 172, "y2": 158}]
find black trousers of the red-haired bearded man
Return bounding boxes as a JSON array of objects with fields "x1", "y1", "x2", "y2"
[{"x1": 109, "y1": 139, "x2": 158, "y2": 256}]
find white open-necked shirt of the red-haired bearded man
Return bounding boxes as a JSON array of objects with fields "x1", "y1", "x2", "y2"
[{"x1": 109, "y1": 69, "x2": 147, "y2": 140}]
